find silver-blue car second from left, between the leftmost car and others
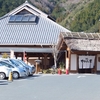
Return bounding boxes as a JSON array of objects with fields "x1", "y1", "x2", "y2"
[{"x1": 0, "y1": 61, "x2": 27, "y2": 79}]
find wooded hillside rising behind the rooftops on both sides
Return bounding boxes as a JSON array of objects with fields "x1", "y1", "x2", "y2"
[{"x1": 0, "y1": 0, "x2": 100, "y2": 32}]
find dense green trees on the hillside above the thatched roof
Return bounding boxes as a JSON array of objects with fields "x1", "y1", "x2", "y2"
[{"x1": 70, "y1": 0, "x2": 100, "y2": 32}]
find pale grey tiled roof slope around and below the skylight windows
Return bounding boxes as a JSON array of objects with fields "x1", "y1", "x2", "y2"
[{"x1": 0, "y1": 2, "x2": 70, "y2": 45}]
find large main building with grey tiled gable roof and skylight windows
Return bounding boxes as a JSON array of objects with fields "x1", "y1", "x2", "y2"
[{"x1": 0, "y1": 1, "x2": 70, "y2": 69}]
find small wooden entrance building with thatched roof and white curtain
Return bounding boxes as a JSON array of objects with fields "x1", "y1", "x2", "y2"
[{"x1": 57, "y1": 32, "x2": 100, "y2": 73}]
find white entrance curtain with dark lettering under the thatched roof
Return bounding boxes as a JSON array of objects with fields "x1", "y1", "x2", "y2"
[{"x1": 79, "y1": 56, "x2": 95, "y2": 69}]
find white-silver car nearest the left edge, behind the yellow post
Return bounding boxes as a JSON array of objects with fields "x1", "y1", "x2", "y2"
[{"x1": 0, "y1": 63, "x2": 12, "y2": 79}]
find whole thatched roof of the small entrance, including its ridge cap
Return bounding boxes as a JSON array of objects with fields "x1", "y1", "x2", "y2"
[{"x1": 58, "y1": 32, "x2": 100, "y2": 51}]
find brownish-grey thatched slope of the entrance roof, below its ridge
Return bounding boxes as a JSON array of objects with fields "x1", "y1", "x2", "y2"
[{"x1": 65, "y1": 39, "x2": 100, "y2": 51}]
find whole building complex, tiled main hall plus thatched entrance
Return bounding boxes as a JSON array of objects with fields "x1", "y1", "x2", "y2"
[{"x1": 0, "y1": 1, "x2": 100, "y2": 73}]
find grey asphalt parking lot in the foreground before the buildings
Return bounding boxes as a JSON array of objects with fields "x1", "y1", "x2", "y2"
[{"x1": 0, "y1": 74, "x2": 100, "y2": 100}]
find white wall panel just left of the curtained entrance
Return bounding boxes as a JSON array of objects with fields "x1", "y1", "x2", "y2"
[{"x1": 70, "y1": 54, "x2": 77, "y2": 70}]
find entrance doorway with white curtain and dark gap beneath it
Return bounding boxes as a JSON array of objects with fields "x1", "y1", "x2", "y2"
[{"x1": 78, "y1": 55, "x2": 95, "y2": 73}]
